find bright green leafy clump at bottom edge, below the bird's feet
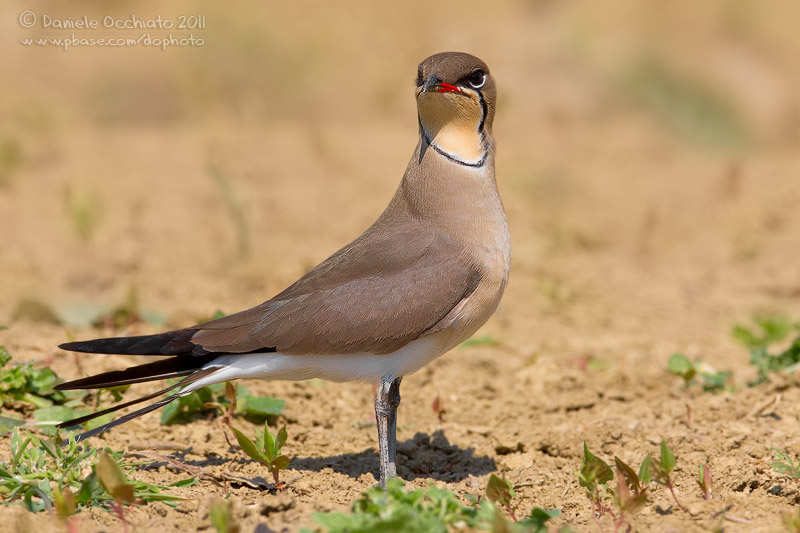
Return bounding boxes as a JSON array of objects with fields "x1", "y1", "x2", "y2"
[{"x1": 305, "y1": 478, "x2": 567, "y2": 533}]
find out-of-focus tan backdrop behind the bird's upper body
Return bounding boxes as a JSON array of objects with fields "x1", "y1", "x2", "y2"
[{"x1": 0, "y1": 0, "x2": 800, "y2": 357}]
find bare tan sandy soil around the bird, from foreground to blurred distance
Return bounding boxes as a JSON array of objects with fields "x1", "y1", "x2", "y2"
[{"x1": 0, "y1": 2, "x2": 800, "y2": 532}]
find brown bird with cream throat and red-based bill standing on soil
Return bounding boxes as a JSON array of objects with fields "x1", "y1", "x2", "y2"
[{"x1": 56, "y1": 52, "x2": 511, "y2": 488}]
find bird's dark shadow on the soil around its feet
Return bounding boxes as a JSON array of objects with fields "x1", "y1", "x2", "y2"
[{"x1": 291, "y1": 430, "x2": 497, "y2": 482}]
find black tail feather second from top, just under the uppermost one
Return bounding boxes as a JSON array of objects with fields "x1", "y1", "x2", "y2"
[{"x1": 55, "y1": 355, "x2": 215, "y2": 390}]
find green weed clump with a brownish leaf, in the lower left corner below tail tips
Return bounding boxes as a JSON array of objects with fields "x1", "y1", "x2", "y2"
[{"x1": 0, "y1": 428, "x2": 196, "y2": 510}]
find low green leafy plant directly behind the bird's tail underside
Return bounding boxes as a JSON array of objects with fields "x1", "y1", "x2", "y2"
[{"x1": 161, "y1": 381, "x2": 286, "y2": 425}]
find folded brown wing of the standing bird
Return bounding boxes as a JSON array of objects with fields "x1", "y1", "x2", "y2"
[{"x1": 190, "y1": 225, "x2": 480, "y2": 355}]
